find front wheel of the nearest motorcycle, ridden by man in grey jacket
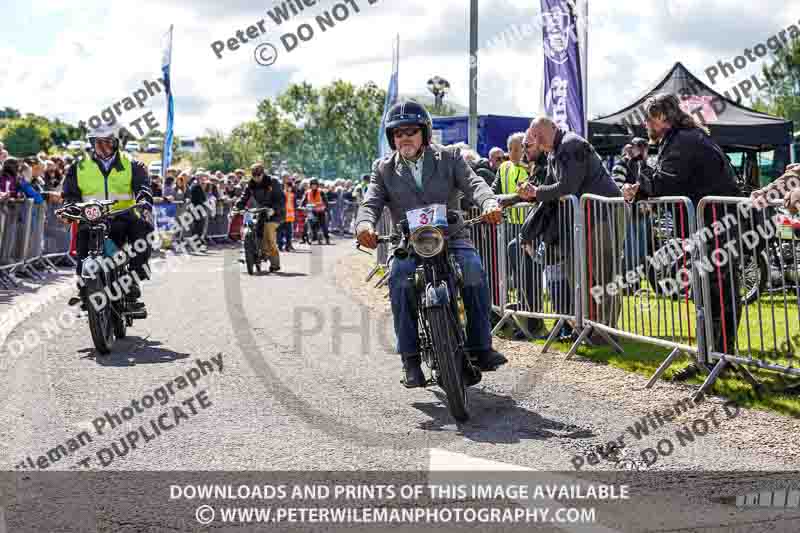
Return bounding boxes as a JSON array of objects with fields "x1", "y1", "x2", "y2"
[{"x1": 428, "y1": 307, "x2": 469, "y2": 422}]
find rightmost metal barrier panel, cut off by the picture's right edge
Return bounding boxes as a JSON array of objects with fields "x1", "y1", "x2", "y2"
[{"x1": 698, "y1": 197, "x2": 800, "y2": 395}]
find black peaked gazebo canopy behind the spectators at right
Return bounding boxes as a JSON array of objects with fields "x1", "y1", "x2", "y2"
[{"x1": 589, "y1": 62, "x2": 792, "y2": 156}]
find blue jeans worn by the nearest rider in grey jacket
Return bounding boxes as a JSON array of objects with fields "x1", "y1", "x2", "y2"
[{"x1": 389, "y1": 248, "x2": 492, "y2": 354}]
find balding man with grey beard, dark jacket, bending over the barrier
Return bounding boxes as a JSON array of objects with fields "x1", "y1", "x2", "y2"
[{"x1": 517, "y1": 117, "x2": 623, "y2": 338}]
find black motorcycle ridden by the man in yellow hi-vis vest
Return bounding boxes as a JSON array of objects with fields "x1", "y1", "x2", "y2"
[{"x1": 55, "y1": 200, "x2": 147, "y2": 355}]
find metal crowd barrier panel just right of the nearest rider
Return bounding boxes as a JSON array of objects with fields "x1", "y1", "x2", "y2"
[{"x1": 488, "y1": 196, "x2": 582, "y2": 352}]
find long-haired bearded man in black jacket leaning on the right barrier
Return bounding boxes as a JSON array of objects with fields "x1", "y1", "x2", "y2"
[{"x1": 622, "y1": 93, "x2": 742, "y2": 380}]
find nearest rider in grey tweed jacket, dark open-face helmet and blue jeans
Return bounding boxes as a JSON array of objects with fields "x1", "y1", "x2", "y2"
[{"x1": 356, "y1": 101, "x2": 507, "y2": 388}]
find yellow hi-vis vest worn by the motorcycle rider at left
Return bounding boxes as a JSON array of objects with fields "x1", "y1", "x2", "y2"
[{"x1": 78, "y1": 152, "x2": 136, "y2": 212}]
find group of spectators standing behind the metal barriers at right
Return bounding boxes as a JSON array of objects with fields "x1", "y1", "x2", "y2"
[{"x1": 446, "y1": 94, "x2": 800, "y2": 380}]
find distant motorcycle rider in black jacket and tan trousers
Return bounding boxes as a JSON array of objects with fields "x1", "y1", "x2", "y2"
[{"x1": 236, "y1": 163, "x2": 286, "y2": 272}]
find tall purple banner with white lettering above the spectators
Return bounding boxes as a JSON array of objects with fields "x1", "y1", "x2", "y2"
[{"x1": 541, "y1": 0, "x2": 586, "y2": 137}]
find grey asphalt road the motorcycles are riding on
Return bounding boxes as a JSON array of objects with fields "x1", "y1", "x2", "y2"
[{"x1": 0, "y1": 240, "x2": 800, "y2": 533}]
